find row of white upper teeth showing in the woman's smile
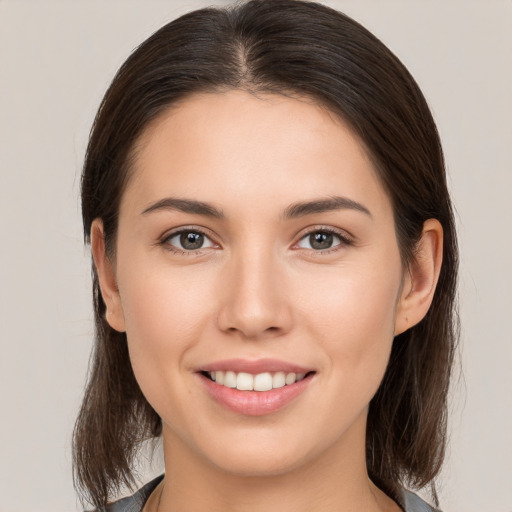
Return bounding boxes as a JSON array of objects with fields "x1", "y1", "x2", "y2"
[{"x1": 204, "y1": 371, "x2": 306, "y2": 391}]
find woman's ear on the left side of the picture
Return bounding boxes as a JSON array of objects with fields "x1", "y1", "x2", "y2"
[{"x1": 91, "y1": 219, "x2": 125, "y2": 332}]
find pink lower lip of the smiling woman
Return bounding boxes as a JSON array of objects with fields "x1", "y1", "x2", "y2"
[{"x1": 198, "y1": 373, "x2": 314, "y2": 416}]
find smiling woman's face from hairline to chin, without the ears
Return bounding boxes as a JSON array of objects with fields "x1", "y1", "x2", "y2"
[{"x1": 97, "y1": 91, "x2": 404, "y2": 475}]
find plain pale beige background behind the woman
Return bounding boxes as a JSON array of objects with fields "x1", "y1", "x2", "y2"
[{"x1": 0, "y1": 0, "x2": 512, "y2": 512}]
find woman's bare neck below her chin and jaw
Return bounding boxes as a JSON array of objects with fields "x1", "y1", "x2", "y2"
[{"x1": 156, "y1": 420, "x2": 399, "y2": 512}]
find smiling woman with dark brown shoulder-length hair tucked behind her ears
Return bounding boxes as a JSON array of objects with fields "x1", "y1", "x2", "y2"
[{"x1": 74, "y1": 0, "x2": 457, "y2": 512}]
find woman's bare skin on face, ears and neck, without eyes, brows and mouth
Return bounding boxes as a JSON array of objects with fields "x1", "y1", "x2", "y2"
[{"x1": 91, "y1": 91, "x2": 442, "y2": 512}]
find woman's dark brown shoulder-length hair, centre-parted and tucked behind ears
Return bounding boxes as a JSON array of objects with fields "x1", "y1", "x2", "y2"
[{"x1": 73, "y1": 0, "x2": 457, "y2": 508}]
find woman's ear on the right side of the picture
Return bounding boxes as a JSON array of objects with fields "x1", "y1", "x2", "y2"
[{"x1": 395, "y1": 219, "x2": 443, "y2": 336}]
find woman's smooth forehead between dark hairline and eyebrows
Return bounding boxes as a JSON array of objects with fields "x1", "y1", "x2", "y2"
[{"x1": 123, "y1": 91, "x2": 386, "y2": 220}]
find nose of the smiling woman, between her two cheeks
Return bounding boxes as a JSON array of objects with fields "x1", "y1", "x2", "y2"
[{"x1": 217, "y1": 248, "x2": 292, "y2": 340}]
